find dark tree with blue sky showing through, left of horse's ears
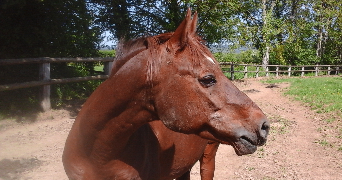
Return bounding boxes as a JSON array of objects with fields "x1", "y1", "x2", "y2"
[{"x1": 90, "y1": 0, "x2": 182, "y2": 40}]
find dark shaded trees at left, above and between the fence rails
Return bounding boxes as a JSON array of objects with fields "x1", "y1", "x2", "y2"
[{"x1": 0, "y1": 0, "x2": 101, "y2": 114}]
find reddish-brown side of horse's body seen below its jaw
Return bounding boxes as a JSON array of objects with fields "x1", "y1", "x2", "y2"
[{"x1": 149, "y1": 121, "x2": 208, "y2": 178}]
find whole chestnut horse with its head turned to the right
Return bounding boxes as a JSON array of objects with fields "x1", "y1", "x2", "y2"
[{"x1": 63, "y1": 10, "x2": 269, "y2": 180}]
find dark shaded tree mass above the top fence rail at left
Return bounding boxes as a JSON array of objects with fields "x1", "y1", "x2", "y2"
[{"x1": 0, "y1": 0, "x2": 101, "y2": 58}]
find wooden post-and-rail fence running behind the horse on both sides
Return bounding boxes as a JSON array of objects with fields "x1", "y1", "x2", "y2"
[{"x1": 0, "y1": 57, "x2": 342, "y2": 111}]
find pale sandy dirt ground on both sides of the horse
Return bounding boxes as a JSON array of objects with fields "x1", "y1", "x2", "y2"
[{"x1": 0, "y1": 79, "x2": 342, "y2": 180}]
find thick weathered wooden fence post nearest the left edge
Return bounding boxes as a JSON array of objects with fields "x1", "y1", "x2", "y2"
[{"x1": 39, "y1": 63, "x2": 51, "y2": 111}]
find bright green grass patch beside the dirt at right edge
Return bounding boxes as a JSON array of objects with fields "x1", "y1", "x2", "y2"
[{"x1": 267, "y1": 77, "x2": 342, "y2": 113}]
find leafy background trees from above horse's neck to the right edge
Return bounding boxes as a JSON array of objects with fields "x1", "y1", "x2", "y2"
[{"x1": 90, "y1": 0, "x2": 342, "y2": 65}]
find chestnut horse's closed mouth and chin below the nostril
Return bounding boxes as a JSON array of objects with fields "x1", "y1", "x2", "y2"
[{"x1": 232, "y1": 136, "x2": 257, "y2": 156}]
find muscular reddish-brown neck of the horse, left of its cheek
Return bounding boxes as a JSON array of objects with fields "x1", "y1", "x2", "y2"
[{"x1": 76, "y1": 51, "x2": 154, "y2": 161}]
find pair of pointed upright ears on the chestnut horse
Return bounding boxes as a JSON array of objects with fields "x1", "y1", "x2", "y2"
[{"x1": 169, "y1": 8, "x2": 197, "y2": 49}]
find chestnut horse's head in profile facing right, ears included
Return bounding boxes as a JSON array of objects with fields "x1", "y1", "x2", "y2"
[{"x1": 147, "y1": 10, "x2": 270, "y2": 155}]
